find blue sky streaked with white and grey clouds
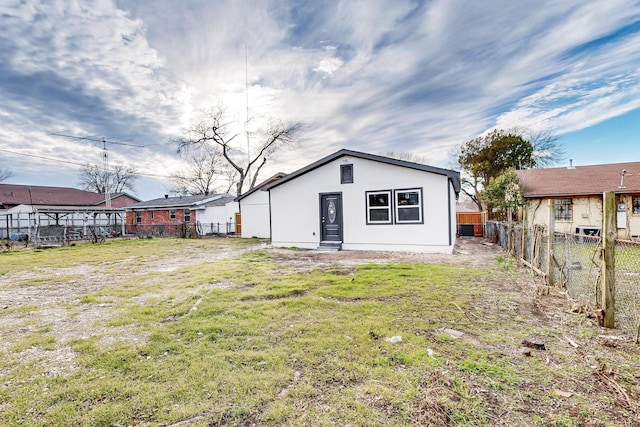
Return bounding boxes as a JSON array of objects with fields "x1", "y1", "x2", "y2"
[{"x1": 0, "y1": 0, "x2": 640, "y2": 199}]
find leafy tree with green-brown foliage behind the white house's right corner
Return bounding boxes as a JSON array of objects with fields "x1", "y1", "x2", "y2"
[{"x1": 456, "y1": 128, "x2": 562, "y2": 210}]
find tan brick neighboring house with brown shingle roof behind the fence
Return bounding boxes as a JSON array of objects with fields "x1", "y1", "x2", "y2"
[{"x1": 516, "y1": 162, "x2": 640, "y2": 239}]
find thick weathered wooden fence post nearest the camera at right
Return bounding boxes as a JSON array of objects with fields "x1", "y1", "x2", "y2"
[{"x1": 601, "y1": 191, "x2": 617, "y2": 328}]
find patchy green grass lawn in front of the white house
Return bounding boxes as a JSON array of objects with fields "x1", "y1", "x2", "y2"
[{"x1": 0, "y1": 239, "x2": 640, "y2": 426}]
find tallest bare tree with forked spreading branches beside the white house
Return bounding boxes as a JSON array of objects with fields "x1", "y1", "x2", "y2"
[{"x1": 171, "y1": 106, "x2": 302, "y2": 196}]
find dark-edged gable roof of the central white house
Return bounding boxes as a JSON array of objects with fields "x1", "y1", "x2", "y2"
[{"x1": 265, "y1": 149, "x2": 460, "y2": 195}]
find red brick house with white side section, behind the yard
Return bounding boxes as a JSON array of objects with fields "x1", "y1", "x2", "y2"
[{"x1": 126, "y1": 193, "x2": 237, "y2": 235}]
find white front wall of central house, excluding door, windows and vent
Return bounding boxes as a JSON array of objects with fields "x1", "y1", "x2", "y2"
[{"x1": 270, "y1": 157, "x2": 455, "y2": 253}]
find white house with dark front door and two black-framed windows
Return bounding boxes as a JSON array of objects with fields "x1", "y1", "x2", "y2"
[{"x1": 260, "y1": 150, "x2": 460, "y2": 253}]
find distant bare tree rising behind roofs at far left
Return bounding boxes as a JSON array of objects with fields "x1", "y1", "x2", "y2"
[{"x1": 80, "y1": 163, "x2": 138, "y2": 194}]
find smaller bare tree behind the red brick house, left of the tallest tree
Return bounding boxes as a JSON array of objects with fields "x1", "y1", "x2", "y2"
[{"x1": 169, "y1": 144, "x2": 235, "y2": 195}]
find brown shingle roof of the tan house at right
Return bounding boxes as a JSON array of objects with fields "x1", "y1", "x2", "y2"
[{"x1": 516, "y1": 162, "x2": 640, "y2": 198}]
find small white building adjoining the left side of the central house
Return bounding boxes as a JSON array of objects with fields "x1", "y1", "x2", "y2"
[{"x1": 236, "y1": 172, "x2": 286, "y2": 239}]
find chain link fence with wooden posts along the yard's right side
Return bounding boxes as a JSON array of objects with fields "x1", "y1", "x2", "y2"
[{"x1": 485, "y1": 221, "x2": 640, "y2": 336}]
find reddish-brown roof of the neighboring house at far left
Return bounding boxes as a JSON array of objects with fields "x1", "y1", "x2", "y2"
[{"x1": 0, "y1": 184, "x2": 140, "y2": 209}]
